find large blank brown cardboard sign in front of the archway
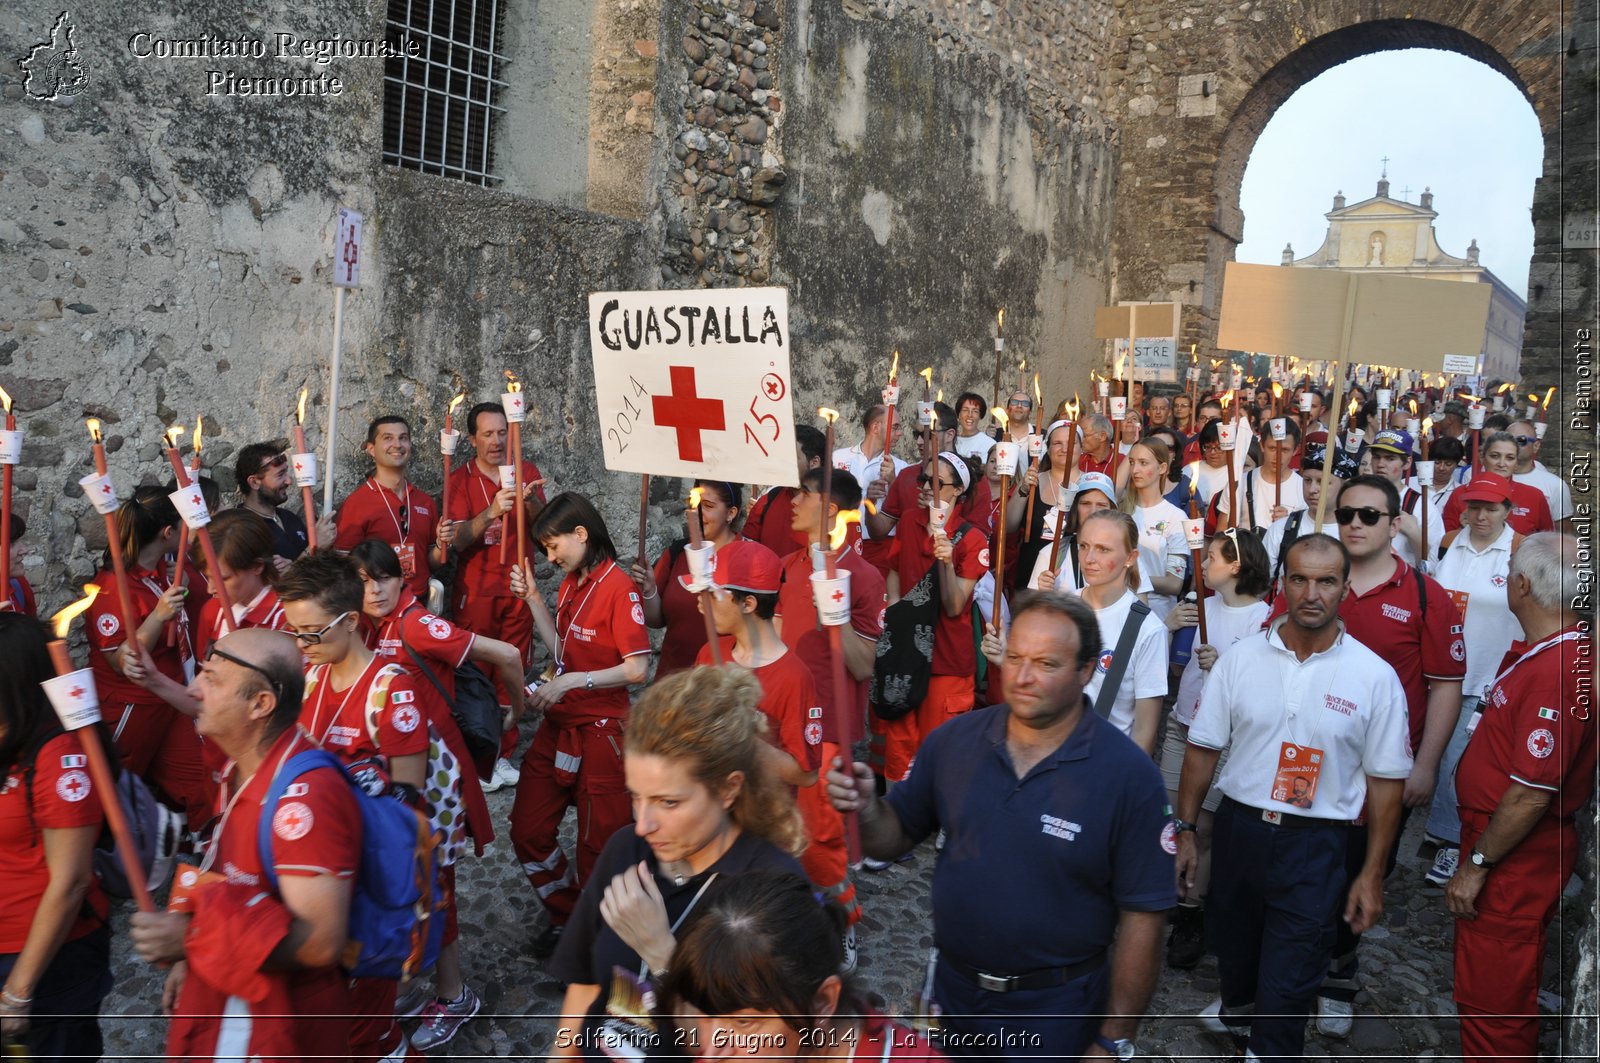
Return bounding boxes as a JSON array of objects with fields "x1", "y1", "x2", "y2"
[{"x1": 1216, "y1": 263, "x2": 1490, "y2": 373}]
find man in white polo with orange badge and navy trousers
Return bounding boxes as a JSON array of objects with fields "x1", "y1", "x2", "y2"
[{"x1": 1174, "y1": 535, "x2": 1411, "y2": 1058}]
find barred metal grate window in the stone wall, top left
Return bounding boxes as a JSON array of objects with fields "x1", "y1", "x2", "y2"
[{"x1": 384, "y1": 0, "x2": 506, "y2": 186}]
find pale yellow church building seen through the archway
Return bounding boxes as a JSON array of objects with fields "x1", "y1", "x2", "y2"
[{"x1": 1283, "y1": 176, "x2": 1528, "y2": 379}]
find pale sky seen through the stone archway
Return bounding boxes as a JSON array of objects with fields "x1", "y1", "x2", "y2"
[{"x1": 1238, "y1": 48, "x2": 1544, "y2": 298}]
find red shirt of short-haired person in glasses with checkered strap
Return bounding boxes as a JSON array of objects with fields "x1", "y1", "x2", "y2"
[{"x1": 301, "y1": 656, "x2": 427, "y2": 764}]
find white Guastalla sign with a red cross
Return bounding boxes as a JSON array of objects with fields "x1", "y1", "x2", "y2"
[{"x1": 589, "y1": 281, "x2": 798, "y2": 487}]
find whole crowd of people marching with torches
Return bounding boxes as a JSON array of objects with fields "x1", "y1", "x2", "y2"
[{"x1": 0, "y1": 368, "x2": 1597, "y2": 1061}]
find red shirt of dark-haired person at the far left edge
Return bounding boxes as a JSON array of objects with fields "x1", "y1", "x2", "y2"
[{"x1": 0, "y1": 733, "x2": 106, "y2": 953}]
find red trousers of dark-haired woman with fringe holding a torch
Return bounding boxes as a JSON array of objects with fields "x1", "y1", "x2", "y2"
[{"x1": 510, "y1": 717, "x2": 634, "y2": 925}]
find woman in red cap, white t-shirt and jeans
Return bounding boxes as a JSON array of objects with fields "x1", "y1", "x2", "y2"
[{"x1": 1427, "y1": 474, "x2": 1522, "y2": 885}]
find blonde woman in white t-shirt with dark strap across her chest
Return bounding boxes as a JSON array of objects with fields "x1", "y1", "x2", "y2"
[{"x1": 1078, "y1": 509, "x2": 1166, "y2": 756}]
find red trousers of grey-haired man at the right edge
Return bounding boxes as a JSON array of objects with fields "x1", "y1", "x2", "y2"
[{"x1": 1456, "y1": 808, "x2": 1578, "y2": 1061}]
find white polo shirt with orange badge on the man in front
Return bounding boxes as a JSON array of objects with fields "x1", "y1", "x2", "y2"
[{"x1": 1189, "y1": 616, "x2": 1411, "y2": 820}]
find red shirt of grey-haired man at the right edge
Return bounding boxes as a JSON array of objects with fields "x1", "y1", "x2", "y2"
[{"x1": 1456, "y1": 624, "x2": 1595, "y2": 820}]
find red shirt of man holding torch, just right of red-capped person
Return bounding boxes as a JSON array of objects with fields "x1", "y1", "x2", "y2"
[{"x1": 778, "y1": 540, "x2": 888, "y2": 744}]
